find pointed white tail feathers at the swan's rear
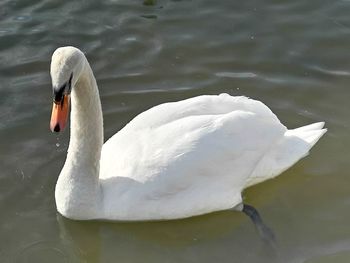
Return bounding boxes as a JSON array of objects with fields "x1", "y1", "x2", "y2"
[{"x1": 246, "y1": 122, "x2": 327, "y2": 187}]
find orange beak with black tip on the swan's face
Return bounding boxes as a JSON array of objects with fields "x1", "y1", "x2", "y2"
[{"x1": 50, "y1": 95, "x2": 70, "y2": 132}]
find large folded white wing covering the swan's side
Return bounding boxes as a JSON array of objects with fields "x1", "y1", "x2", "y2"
[{"x1": 100, "y1": 96, "x2": 286, "y2": 218}]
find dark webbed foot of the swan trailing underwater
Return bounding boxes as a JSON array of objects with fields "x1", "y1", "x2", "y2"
[{"x1": 241, "y1": 204, "x2": 276, "y2": 247}]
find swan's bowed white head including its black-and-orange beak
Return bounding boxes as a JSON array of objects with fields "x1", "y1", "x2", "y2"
[{"x1": 50, "y1": 47, "x2": 85, "y2": 132}]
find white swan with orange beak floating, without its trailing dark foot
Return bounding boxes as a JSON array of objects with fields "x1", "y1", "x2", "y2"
[{"x1": 50, "y1": 47, "x2": 326, "y2": 220}]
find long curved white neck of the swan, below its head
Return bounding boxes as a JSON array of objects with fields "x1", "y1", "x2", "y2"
[{"x1": 55, "y1": 60, "x2": 103, "y2": 219}]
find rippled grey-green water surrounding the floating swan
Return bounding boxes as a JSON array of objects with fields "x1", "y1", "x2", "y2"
[{"x1": 0, "y1": 0, "x2": 350, "y2": 263}]
